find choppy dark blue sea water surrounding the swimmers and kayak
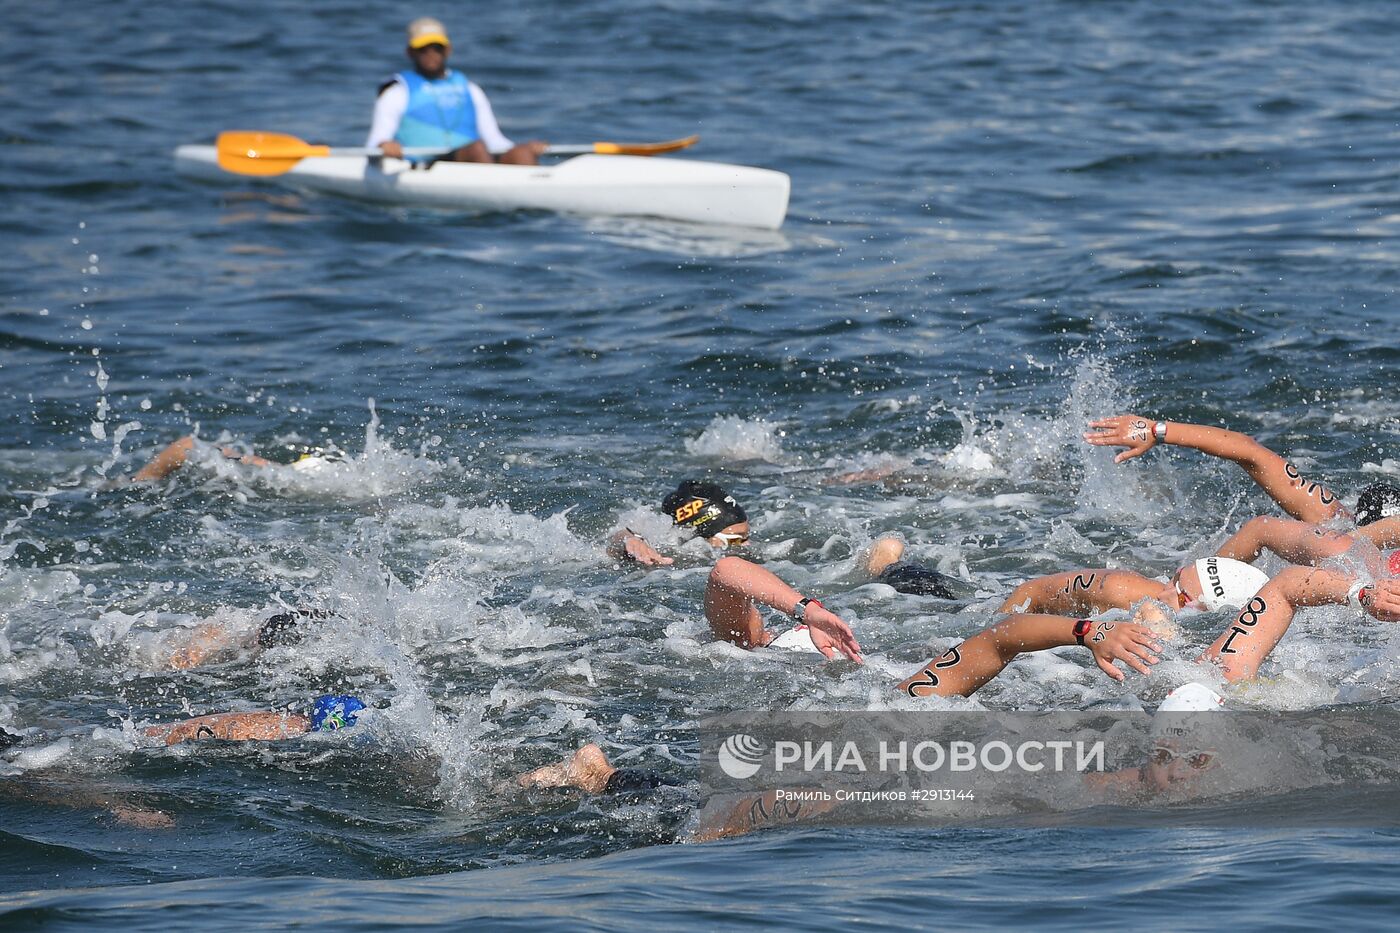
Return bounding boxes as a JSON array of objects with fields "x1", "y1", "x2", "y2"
[{"x1": 0, "y1": 0, "x2": 1400, "y2": 929}]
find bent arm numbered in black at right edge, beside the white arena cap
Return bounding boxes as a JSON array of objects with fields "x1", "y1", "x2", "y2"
[{"x1": 1201, "y1": 567, "x2": 1400, "y2": 682}]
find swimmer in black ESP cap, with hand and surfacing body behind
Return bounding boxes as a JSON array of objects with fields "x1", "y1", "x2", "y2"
[{"x1": 608, "y1": 479, "x2": 953, "y2": 600}]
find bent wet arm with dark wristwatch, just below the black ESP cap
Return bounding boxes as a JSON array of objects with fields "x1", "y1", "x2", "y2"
[{"x1": 704, "y1": 558, "x2": 865, "y2": 663}]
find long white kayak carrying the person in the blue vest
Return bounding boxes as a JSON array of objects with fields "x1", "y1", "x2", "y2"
[{"x1": 175, "y1": 146, "x2": 791, "y2": 230}]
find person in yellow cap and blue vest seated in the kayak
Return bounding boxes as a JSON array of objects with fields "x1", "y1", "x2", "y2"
[{"x1": 365, "y1": 17, "x2": 547, "y2": 165}]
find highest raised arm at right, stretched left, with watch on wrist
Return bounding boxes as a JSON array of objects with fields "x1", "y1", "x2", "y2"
[{"x1": 1084, "y1": 415, "x2": 1341, "y2": 521}]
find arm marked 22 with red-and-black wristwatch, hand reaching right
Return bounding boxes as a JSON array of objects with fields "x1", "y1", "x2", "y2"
[{"x1": 899, "y1": 615, "x2": 1162, "y2": 698}]
